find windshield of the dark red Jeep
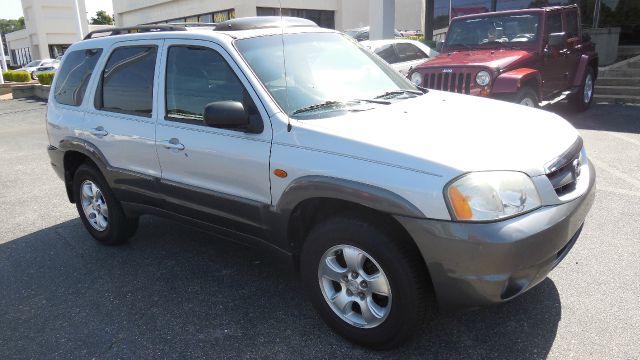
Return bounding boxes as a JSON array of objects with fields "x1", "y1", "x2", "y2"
[{"x1": 445, "y1": 14, "x2": 540, "y2": 51}]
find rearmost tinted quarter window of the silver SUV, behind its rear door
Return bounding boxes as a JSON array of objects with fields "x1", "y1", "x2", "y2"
[{"x1": 53, "y1": 49, "x2": 102, "y2": 106}]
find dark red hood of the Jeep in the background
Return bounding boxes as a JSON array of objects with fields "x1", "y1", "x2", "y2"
[{"x1": 418, "y1": 49, "x2": 533, "y2": 70}]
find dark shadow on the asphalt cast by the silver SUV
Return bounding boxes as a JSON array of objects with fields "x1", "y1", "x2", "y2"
[{"x1": 0, "y1": 217, "x2": 561, "y2": 359}]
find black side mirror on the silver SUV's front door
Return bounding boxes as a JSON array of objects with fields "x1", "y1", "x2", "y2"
[{"x1": 204, "y1": 101, "x2": 262, "y2": 133}]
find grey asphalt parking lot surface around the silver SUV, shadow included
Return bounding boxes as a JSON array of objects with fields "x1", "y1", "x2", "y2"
[{"x1": 0, "y1": 100, "x2": 640, "y2": 359}]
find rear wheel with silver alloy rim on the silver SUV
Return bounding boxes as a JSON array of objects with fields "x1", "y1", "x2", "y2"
[{"x1": 73, "y1": 164, "x2": 138, "y2": 245}]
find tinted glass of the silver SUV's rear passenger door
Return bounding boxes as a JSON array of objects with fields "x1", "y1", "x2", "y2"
[{"x1": 95, "y1": 46, "x2": 157, "y2": 117}]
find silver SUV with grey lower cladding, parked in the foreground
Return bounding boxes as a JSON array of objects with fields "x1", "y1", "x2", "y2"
[{"x1": 47, "y1": 17, "x2": 595, "y2": 348}]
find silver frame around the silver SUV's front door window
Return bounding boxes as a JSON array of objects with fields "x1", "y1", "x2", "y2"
[{"x1": 156, "y1": 39, "x2": 271, "y2": 136}]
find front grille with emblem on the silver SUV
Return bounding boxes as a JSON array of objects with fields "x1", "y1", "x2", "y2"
[{"x1": 545, "y1": 138, "x2": 582, "y2": 196}]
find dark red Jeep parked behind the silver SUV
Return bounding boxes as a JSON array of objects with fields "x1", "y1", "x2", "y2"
[{"x1": 408, "y1": 5, "x2": 598, "y2": 111}]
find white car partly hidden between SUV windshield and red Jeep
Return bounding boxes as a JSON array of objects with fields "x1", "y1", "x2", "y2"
[{"x1": 360, "y1": 39, "x2": 438, "y2": 76}]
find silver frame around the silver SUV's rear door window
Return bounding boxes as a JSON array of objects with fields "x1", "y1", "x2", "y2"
[{"x1": 91, "y1": 40, "x2": 164, "y2": 119}]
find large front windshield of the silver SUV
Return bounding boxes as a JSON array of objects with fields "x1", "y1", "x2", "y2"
[{"x1": 235, "y1": 33, "x2": 422, "y2": 119}]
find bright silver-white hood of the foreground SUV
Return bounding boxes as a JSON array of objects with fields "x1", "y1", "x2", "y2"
[{"x1": 294, "y1": 90, "x2": 578, "y2": 178}]
